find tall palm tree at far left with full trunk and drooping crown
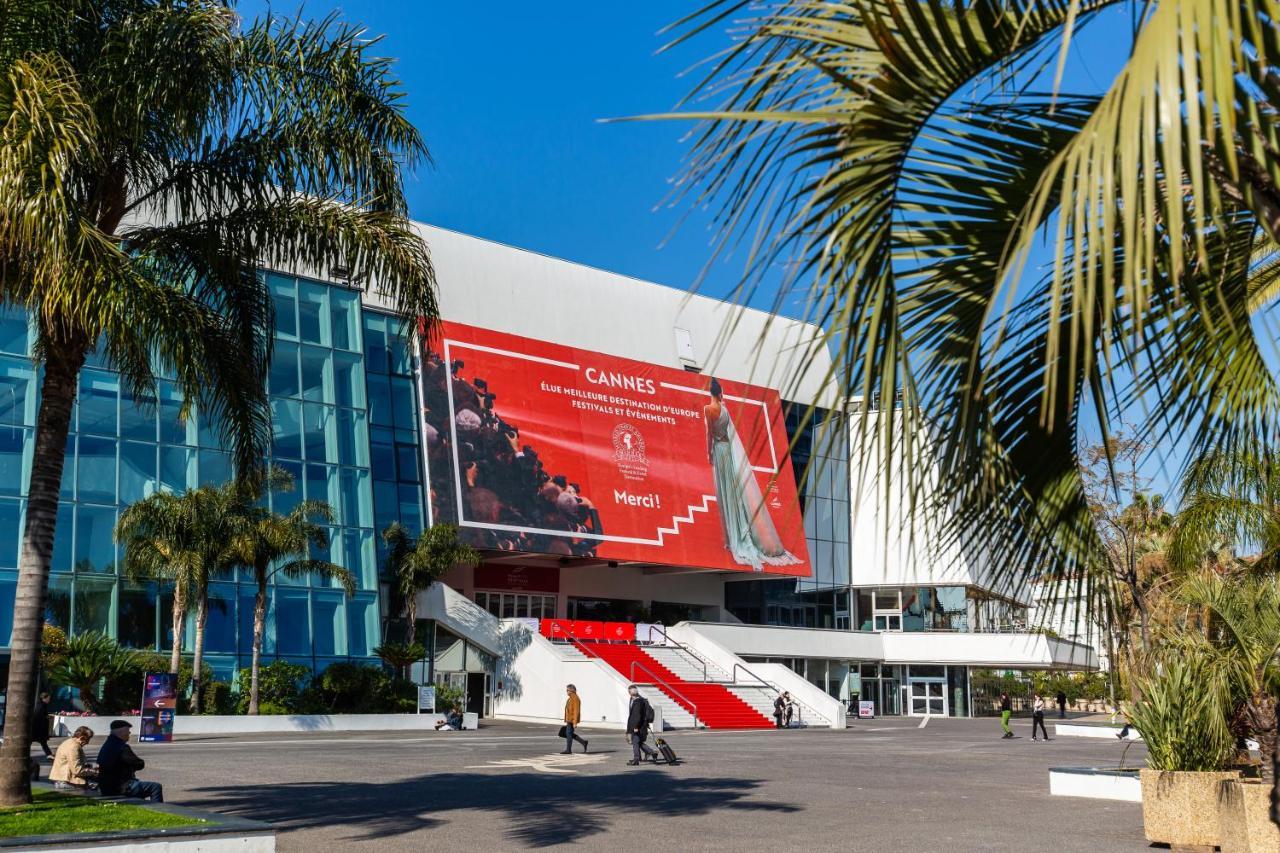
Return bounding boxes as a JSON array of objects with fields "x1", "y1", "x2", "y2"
[{"x1": 0, "y1": 0, "x2": 436, "y2": 806}]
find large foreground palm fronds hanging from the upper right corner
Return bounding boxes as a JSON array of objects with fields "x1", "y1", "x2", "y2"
[{"x1": 652, "y1": 0, "x2": 1280, "y2": 822}]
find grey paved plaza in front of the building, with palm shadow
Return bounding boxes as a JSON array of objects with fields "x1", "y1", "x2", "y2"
[{"x1": 132, "y1": 719, "x2": 1148, "y2": 853}]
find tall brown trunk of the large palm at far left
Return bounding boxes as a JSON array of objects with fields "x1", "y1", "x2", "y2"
[{"x1": 0, "y1": 346, "x2": 84, "y2": 806}]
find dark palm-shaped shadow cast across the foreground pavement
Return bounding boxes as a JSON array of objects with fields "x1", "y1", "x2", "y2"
[{"x1": 187, "y1": 770, "x2": 801, "y2": 848}]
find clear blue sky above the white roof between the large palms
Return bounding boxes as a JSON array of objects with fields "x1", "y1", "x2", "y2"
[{"x1": 239, "y1": 0, "x2": 741, "y2": 303}]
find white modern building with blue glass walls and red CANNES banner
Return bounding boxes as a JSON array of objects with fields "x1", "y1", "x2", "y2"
[{"x1": 0, "y1": 225, "x2": 1097, "y2": 722}]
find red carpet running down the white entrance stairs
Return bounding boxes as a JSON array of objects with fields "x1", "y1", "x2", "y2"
[{"x1": 575, "y1": 640, "x2": 773, "y2": 729}]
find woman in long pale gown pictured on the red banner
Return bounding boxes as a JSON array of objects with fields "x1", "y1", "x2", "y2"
[{"x1": 703, "y1": 379, "x2": 800, "y2": 563}]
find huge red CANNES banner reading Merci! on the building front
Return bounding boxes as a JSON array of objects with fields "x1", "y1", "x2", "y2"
[{"x1": 424, "y1": 323, "x2": 810, "y2": 576}]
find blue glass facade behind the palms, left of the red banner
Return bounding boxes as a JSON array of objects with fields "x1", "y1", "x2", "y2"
[{"x1": 0, "y1": 274, "x2": 422, "y2": 679}]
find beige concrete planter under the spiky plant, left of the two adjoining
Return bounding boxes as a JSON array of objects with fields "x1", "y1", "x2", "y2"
[{"x1": 1139, "y1": 770, "x2": 1239, "y2": 848}]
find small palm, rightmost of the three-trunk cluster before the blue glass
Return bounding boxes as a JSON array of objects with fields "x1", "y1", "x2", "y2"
[{"x1": 232, "y1": 469, "x2": 356, "y2": 715}]
